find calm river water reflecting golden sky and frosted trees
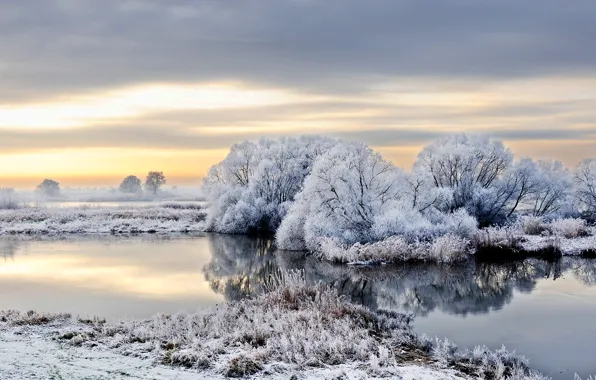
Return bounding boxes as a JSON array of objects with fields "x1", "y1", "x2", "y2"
[{"x1": 0, "y1": 235, "x2": 596, "y2": 379}]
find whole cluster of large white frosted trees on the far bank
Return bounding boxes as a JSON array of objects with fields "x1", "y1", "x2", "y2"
[{"x1": 204, "y1": 134, "x2": 596, "y2": 254}]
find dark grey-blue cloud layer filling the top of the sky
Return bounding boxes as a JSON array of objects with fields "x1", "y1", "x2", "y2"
[{"x1": 0, "y1": 0, "x2": 596, "y2": 102}]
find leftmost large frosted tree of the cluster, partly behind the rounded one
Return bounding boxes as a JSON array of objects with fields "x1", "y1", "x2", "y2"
[{"x1": 204, "y1": 136, "x2": 337, "y2": 233}]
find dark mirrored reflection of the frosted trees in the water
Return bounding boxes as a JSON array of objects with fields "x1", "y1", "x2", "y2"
[{"x1": 203, "y1": 235, "x2": 596, "y2": 316}]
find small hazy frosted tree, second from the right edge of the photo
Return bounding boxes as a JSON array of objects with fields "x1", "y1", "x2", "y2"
[{"x1": 529, "y1": 160, "x2": 573, "y2": 216}]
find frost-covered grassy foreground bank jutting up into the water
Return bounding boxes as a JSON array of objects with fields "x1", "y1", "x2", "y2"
[{"x1": 0, "y1": 273, "x2": 545, "y2": 379}]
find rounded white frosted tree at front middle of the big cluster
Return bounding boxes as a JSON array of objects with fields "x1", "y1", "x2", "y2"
[{"x1": 277, "y1": 143, "x2": 404, "y2": 249}]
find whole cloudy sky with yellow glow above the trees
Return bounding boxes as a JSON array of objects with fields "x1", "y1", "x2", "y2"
[{"x1": 0, "y1": 0, "x2": 596, "y2": 188}]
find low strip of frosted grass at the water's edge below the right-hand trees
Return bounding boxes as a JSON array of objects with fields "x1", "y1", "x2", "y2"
[{"x1": 315, "y1": 217, "x2": 596, "y2": 265}]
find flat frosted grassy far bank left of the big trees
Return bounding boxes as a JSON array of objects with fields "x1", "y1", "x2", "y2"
[{"x1": 0, "y1": 203, "x2": 205, "y2": 236}]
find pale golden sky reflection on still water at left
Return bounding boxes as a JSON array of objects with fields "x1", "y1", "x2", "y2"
[{"x1": 0, "y1": 236, "x2": 224, "y2": 320}]
